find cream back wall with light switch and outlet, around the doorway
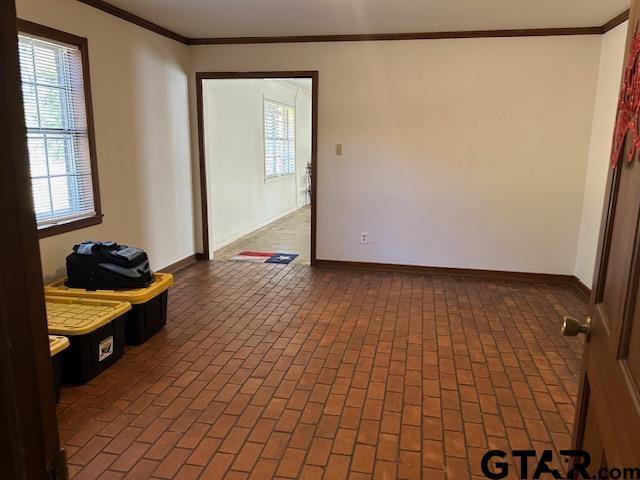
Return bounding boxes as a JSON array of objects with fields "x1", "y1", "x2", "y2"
[{"x1": 191, "y1": 36, "x2": 601, "y2": 275}]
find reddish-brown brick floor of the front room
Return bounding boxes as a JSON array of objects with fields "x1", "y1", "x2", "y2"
[{"x1": 58, "y1": 262, "x2": 586, "y2": 480}]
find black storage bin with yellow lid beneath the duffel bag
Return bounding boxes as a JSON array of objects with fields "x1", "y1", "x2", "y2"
[{"x1": 45, "y1": 272, "x2": 173, "y2": 345}]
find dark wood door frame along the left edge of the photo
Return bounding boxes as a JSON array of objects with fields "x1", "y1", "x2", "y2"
[{"x1": 0, "y1": 0, "x2": 68, "y2": 474}]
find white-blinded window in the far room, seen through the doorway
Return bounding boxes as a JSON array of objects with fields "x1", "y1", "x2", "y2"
[{"x1": 264, "y1": 99, "x2": 296, "y2": 178}]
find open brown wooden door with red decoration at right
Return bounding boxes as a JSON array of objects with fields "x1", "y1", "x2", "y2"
[{"x1": 574, "y1": 0, "x2": 640, "y2": 472}]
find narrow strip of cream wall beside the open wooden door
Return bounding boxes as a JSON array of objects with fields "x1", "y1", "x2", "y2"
[{"x1": 575, "y1": 22, "x2": 628, "y2": 287}]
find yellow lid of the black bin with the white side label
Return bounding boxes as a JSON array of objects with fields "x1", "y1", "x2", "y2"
[{"x1": 45, "y1": 296, "x2": 131, "y2": 336}]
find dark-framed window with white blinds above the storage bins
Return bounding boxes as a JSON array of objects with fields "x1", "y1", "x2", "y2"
[{"x1": 18, "y1": 21, "x2": 101, "y2": 237}]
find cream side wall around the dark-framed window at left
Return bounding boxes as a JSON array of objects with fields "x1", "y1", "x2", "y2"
[{"x1": 17, "y1": 0, "x2": 195, "y2": 279}]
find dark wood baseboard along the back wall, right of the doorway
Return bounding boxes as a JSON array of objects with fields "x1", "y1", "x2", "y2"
[{"x1": 315, "y1": 260, "x2": 577, "y2": 286}]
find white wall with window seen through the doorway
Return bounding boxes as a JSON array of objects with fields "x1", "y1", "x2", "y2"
[{"x1": 203, "y1": 79, "x2": 311, "y2": 252}]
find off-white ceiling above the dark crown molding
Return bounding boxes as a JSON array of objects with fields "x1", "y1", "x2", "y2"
[{"x1": 107, "y1": 0, "x2": 629, "y2": 38}]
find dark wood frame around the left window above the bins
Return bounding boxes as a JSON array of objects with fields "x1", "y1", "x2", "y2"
[{"x1": 16, "y1": 18, "x2": 103, "y2": 238}]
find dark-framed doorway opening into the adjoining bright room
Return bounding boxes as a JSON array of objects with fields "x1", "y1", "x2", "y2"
[{"x1": 196, "y1": 72, "x2": 318, "y2": 265}]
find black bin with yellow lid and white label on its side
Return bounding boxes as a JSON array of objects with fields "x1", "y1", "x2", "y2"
[{"x1": 45, "y1": 296, "x2": 131, "y2": 384}]
